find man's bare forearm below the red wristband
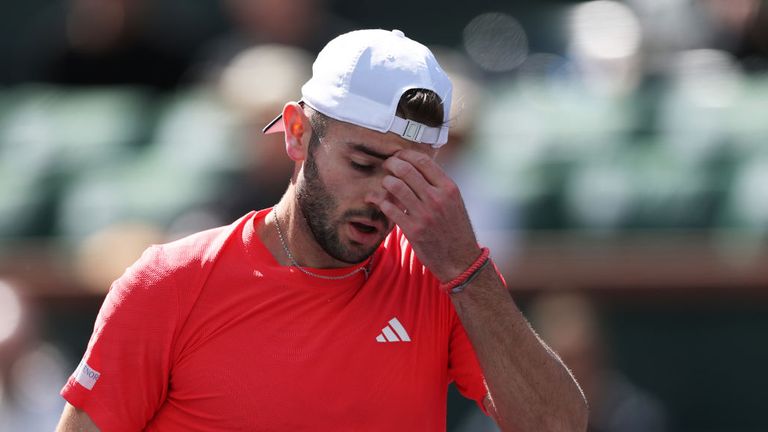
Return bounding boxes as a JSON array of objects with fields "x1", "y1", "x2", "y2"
[{"x1": 451, "y1": 266, "x2": 587, "y2": 432}]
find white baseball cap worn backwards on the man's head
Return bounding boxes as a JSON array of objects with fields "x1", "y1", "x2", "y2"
[{"x1": 263, "y1": 30, "x2": 453, "y2": 148}]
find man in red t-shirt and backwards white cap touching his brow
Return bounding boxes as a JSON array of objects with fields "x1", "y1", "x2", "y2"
[{"x1": 59, "y1": 30, "x2": 587, "y2": 432}]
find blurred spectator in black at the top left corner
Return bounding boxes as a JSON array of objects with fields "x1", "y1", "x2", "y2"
[{"x1": 18, "y1": 0, "x2": 188, "y2": 90}]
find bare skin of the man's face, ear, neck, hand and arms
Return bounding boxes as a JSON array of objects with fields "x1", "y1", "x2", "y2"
[{"x1": 57, "y1": 102, "x2": 587, "y2": 432}]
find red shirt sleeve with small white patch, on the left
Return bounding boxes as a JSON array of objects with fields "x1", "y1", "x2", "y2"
[{"x1": 61, "y1": 246, "x2": 179, "y2": 431}]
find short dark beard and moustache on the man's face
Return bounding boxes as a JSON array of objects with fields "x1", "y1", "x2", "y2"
[{"x1": 296, "y1": 149, "x2": 390, "y2": 264}]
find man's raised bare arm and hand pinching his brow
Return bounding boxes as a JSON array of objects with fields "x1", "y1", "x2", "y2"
[{"x1": 372, "y1": 150, "x2": 587, "y2": 432}]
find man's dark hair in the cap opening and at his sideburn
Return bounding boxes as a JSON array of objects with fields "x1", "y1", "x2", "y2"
[{"x1": 309, "y1": 88, "x2": 443, "y2": 153}]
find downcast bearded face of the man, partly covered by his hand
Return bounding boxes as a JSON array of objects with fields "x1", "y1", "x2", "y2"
[{"x1": 297, "y1": 121, "x2": 436, "y2": 263}]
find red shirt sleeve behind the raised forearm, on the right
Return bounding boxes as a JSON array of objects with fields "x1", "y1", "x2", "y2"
[{"x1": 448, "y1": 309, "x2": 488, "y2": 414}]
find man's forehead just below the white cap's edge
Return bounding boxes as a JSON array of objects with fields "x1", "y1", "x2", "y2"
[{"x1": 326, "y1": 120, "x2": 437, "y2": 157}]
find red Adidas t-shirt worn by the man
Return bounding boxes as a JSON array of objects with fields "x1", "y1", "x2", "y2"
[{"x1": 61, "y1": 209, "x2": 486, "y2": 431}]
